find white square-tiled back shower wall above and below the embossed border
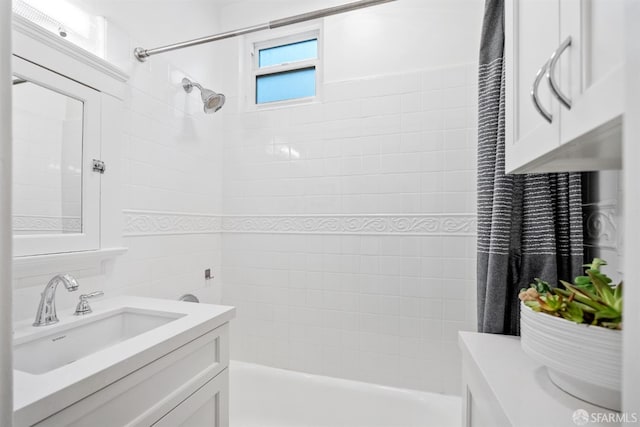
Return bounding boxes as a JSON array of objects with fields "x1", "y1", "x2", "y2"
[{"x1": 222, "y1": 64, "x2": 477, "y2": 393}]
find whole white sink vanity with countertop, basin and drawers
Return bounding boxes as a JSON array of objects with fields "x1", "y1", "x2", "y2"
[{"x1": 14, "y1": 296, "x2": 235, "y2": 427}]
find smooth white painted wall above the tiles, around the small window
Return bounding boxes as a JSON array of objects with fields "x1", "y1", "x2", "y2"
[{"x1": 220, "y1": 0, "x2": 484, "y2": 83}]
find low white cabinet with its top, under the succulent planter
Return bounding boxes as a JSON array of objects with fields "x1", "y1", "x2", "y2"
[{"x1": 458, "y1": 332, "x2": 620, "y2": 427}]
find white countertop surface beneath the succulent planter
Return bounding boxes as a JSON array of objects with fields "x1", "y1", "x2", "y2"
[{"x1": 458, "y1": 332, "x2": 633, "y2": 427}]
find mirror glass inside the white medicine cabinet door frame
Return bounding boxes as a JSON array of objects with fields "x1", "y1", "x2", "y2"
[{"x1": 12, "y1": 76, "x2": 84, "y2": 235}]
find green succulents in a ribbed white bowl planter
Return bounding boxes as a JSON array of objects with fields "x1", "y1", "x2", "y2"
[{"x1": 519, "y1": 258, "x2": 622, "y2": 411}]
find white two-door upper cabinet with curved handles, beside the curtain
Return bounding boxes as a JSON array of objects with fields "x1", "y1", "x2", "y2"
[{"x1": 505, "y1": 0, "x2": 624, "y2": 173}]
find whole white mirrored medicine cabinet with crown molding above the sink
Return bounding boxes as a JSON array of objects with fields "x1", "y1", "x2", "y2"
[{"x1": 12, "y1": 14, "x2": 128, "y2": 260}]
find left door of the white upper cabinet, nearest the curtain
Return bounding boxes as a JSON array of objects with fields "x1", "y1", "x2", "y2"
[{"x1": 505, "y1": 0, "x2": 564, "y2": 172}]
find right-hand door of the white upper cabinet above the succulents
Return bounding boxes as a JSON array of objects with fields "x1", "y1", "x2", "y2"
[{"x1": 560, "y1": 0, "x2": 625, "y2": 169}]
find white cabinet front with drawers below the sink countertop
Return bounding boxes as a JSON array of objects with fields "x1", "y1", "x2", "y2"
[{"x1": 35, "y1": 323, "x2": 229, "y2": 427}]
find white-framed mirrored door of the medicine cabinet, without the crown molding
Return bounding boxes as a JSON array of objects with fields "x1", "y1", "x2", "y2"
[{"x1": 12, "y1": 57, "x2": 100, "y2": 256}]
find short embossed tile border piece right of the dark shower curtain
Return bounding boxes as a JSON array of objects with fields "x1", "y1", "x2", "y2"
[{"x1": 582, "y1": 201, "x2": 622, "y2": 251}]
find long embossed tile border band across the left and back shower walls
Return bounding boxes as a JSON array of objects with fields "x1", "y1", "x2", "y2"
[{"x1": 123, "y1": 210, "x2": 476, "y2": 236}]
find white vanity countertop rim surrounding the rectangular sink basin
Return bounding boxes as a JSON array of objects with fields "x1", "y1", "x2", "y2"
[{"x1": 14, "y1": 296, "x2": 235, "y2": 425}]
